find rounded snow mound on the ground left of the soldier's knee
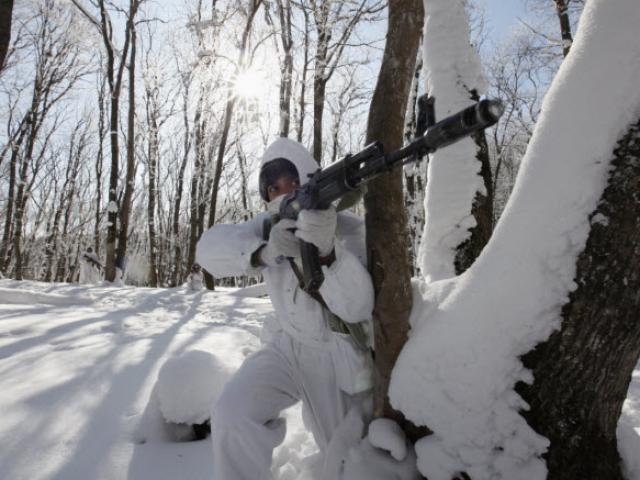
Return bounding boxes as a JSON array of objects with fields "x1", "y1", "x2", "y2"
[{"x1": 156, "y1": 350, "x2": 231, "y2": 425}]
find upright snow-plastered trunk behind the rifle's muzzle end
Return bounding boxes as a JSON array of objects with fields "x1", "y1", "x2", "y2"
[{"x1": 418, "y1": 0, "x2": 492, "y2": 281}]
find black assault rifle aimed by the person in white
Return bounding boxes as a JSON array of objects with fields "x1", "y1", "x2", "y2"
[{"x1": 264, "y1": 96, "x2": 504, "y2": 293}]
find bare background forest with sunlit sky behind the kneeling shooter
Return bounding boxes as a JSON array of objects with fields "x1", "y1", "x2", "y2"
[{"x1": 0, "y1": 0, "x2": 583, "y2": 288}]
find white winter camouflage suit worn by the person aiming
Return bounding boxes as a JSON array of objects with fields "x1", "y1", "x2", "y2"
[{"x1": 196, "y1": 138, "x2": 374, "y2": 480}]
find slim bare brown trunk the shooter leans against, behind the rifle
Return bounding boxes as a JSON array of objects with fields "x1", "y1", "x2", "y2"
[{"x1": 365, "y1": 0, "x2": 424, "y2": 438}]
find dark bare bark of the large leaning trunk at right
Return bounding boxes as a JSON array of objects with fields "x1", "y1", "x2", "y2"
[{"x1": 518, "y1": 120, "x2": 640, "y2": 480}]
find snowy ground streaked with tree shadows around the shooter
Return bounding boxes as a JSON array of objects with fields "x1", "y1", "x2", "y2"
[{"x1": 0, "y1": 280, "x2": 640, "y2": 480}]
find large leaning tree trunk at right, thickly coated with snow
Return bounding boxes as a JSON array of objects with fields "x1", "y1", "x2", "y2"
[{"x1": 390, "y1": 0, "x2": 640, "y2": 480}]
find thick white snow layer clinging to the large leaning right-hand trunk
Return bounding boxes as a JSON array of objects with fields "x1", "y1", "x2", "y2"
[{"x1": 390, "y1": 0, "x2": 640, "y2": 480}]
